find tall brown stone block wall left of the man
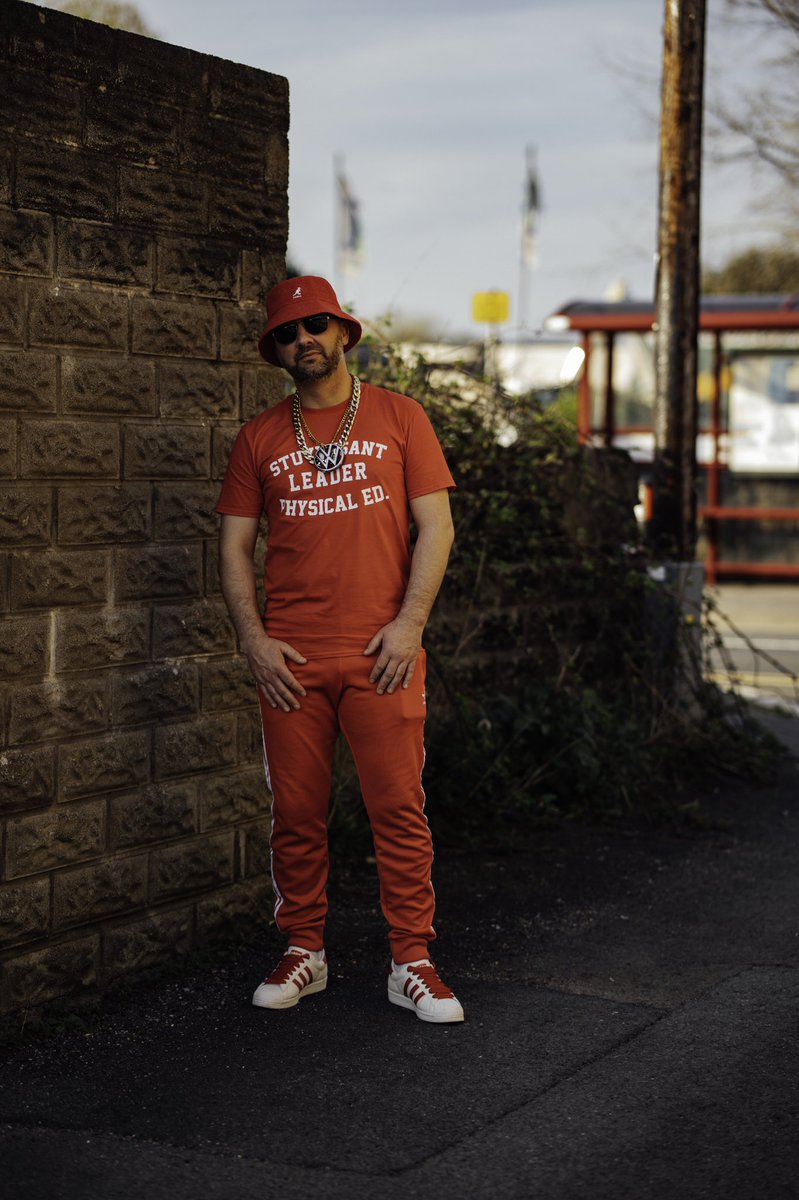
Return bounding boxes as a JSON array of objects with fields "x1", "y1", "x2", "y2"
[{"x1": 0, "y1": 0, "x2": 288, "y2": 1012}]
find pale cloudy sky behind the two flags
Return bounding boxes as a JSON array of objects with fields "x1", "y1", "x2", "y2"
[{"x1": 41, "y1": 0, "x2": 777, "y2": 337}]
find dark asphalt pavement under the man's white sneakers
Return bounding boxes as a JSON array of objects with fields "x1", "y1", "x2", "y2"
[{"x1": 0, "y1": 583, "x2": 799, "y2": 1200}]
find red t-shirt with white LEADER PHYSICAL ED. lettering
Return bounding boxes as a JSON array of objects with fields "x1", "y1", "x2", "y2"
[{"x1": 216, "y1": 383, "x2": 455, "y2": 658}]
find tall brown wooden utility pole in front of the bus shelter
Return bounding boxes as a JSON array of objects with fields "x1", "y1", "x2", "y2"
[{"x1": 649, "y1": 0, "x2": 705, "y2": 563}]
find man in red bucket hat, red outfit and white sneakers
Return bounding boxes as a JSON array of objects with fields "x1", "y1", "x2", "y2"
[{"x1": 217, "y1": 276, "x2": 463, "y2": 1022}]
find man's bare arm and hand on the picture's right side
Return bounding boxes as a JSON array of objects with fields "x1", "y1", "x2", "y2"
[{"x1": 364, "y1": 490, "x2": 455, "y2": 695}]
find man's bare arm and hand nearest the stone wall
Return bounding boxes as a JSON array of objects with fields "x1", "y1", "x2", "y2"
[{"x1": 220, "y1": 514, "x2": 306, "y2": 713}]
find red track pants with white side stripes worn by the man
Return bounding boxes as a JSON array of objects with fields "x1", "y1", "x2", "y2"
[{"x1": 260, "y1": 650, "x2": 435, "y2": 962}]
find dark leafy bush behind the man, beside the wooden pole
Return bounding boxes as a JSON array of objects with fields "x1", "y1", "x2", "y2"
[{"x1": 331, "y1": 348, "x2": 769, "y2": 851}]
